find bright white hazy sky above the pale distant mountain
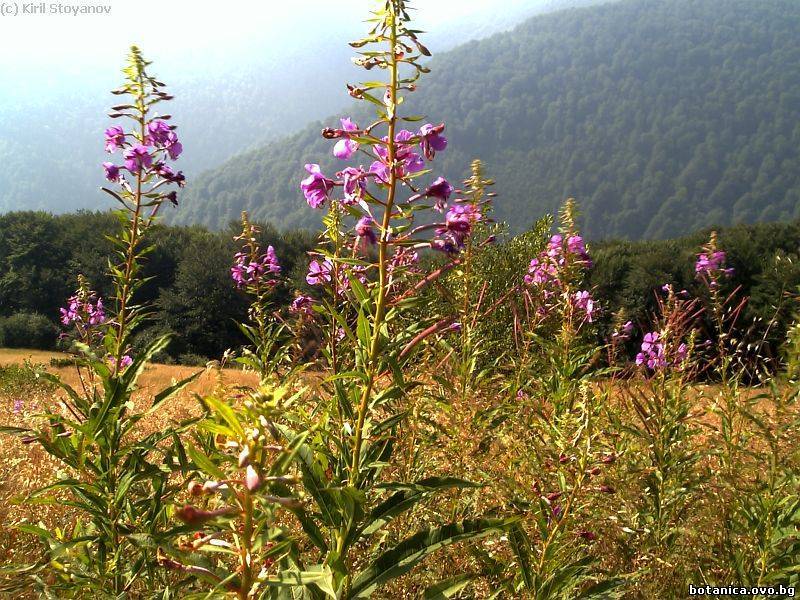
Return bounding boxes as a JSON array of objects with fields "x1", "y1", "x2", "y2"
[{"x1": 0, "y1": 0, "x2": 540, "y2": 74}]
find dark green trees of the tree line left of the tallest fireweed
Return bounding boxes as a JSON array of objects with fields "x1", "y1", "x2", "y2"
[{"x1": 0, "y1": 212, "x2": 314, "y2": 361}]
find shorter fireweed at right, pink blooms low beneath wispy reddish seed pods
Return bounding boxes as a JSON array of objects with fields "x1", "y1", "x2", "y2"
[{"x1": 609, "y1": 284, "x2": 703, "y2": 592}]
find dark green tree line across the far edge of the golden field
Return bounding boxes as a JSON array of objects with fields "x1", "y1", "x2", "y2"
[{"x1": 0, "y1": 212, "x2": 800, "y2": 362}]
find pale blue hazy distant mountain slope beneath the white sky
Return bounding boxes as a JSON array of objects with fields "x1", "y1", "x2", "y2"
[{"x1": 0, "y1": 0, "x2": 598, "y2": 212}]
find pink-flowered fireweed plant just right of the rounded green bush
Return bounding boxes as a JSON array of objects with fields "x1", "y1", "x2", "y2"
[{"x1": 482, "y1": 200, "x2": 620, "y2": 598}]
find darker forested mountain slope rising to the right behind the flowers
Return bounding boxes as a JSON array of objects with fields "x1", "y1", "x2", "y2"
[{"x1": 175, "y1": 0, "x2": 800, "y2": 238}]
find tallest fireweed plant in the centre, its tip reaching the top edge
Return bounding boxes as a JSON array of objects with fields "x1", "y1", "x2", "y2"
[{"x1": 280, "y1": 0, "x2": 509, "y2": 598}]
